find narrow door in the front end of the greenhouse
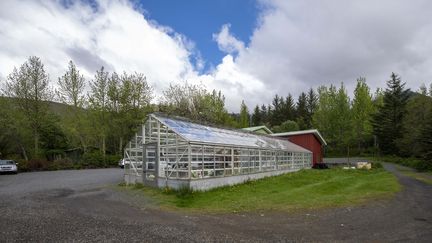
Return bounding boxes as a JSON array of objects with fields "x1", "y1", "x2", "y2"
[{"x1": 143, "y1": 143, "x2": 158, "y2": 186}]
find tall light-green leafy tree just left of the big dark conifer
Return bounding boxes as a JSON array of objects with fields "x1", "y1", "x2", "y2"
[{"x1": 352, "y1": 77, "x2": 375, "y2": 151}]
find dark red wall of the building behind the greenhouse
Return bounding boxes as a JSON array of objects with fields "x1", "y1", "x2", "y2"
[{"x1": 281, "y1": 134, "x2": 322, "y2": 164}]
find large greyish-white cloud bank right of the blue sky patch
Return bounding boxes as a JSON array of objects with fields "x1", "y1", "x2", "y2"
[{"x1": 235, "y1": 0, "x2": 432, "y2": 95}]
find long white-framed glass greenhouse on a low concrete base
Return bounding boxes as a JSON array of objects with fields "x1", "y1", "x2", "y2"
[{"x1": 124, "y1": 114, "x2": 312, "y2": 190}]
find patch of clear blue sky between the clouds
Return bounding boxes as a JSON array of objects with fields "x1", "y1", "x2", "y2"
[{"x1": 139, "y1": 0, "x2": 261, "y2": 72}]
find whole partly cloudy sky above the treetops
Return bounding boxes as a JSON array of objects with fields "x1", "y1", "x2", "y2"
[{"x1": 0, "y1": 0, "x2": 432, "y2": 111}]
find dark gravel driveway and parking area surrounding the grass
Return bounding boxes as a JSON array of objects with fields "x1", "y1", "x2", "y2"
[{"x1": 0, "y1": 164, "x2": 432, "y2": 242}]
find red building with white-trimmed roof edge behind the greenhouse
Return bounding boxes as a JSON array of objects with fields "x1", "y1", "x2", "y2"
[{"x1": 270, "y1": 129, "x2": 327, "y2": 164}]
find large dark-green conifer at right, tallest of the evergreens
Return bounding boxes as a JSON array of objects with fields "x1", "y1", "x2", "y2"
[{"x1": 372, "y1": 73, "x2": 409, "y2": 154}]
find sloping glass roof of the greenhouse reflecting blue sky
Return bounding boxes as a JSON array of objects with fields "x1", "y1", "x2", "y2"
[{"x1": 151, "y1": 114, "x2": 310, "y2": 152}]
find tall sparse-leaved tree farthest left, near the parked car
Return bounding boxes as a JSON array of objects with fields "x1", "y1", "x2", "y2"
[{"x1": 5, "y1": 56, "x2": 53, "y2": 156}]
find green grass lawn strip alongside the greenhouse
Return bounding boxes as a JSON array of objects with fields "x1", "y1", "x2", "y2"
[{"x1": 120, "y1": 169, "x2": 400, "y2": 213}]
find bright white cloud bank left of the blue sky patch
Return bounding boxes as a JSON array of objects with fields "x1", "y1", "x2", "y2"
[{"x1": 0, "y1": 1, "x2": 195, "y2": 96}]
